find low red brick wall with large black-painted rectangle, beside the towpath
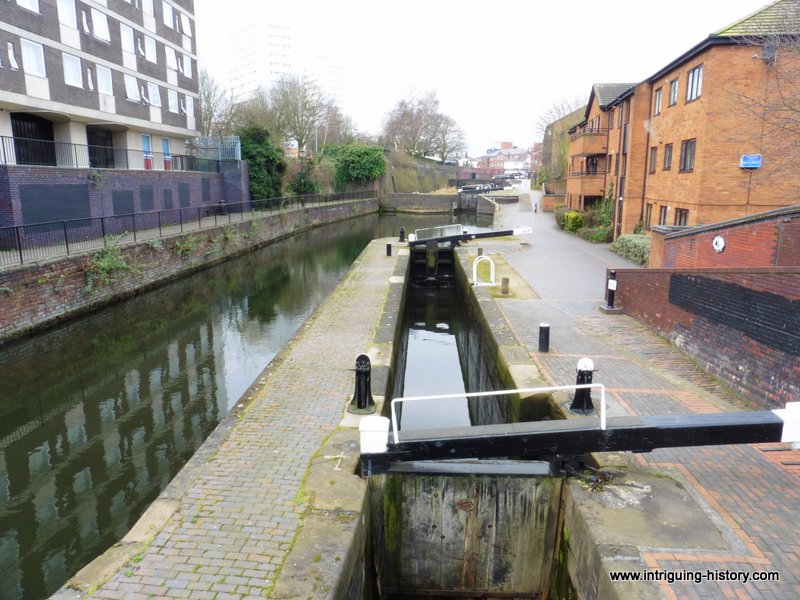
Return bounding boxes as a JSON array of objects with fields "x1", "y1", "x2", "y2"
[{"x1": 615, "y1": 267, "x2": 800, "y2": 408}]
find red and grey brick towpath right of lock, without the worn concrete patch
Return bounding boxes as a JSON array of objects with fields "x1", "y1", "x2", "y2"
[{"x1": 482, "y1": 194, "x2": 800, "y2": 600}]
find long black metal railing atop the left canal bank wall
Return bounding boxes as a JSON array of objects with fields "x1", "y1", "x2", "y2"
[{"x1": 0, "y1": 191, "x2": 375, "y2": 267}]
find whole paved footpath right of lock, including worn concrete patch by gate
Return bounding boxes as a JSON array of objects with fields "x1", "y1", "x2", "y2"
[{"x1": 481, "y1": 192, "x2": 800, "y2": 600}]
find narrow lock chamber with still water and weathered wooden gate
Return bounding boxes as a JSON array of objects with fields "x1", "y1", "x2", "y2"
[{"x1": 366, "y1": 250, "x2": 575, "y2": 600}]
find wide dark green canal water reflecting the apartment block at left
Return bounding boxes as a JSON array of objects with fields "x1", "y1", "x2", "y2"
[{"x1": 0, "y1": 215, "x2": 491, "y2": 600}]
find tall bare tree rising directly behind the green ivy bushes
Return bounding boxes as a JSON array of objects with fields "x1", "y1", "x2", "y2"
[{"x1": 269, "y1": 75, "x2": 328, "y2": 154}]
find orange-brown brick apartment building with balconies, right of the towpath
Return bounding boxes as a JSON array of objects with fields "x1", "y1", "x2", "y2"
[{"x1": 566, "y1": 0, "x2": 800, "y2": 236}]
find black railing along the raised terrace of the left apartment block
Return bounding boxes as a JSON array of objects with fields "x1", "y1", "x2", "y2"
[{"x1": 0, "y1": 136, "x2": 220, "y2": 173}]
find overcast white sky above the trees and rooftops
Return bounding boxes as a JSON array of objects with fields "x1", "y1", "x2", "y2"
[{"x1": 195, "y1": 0, "x2": 769, "y2": 156}]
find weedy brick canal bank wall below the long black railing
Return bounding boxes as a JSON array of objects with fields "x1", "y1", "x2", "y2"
[{"x1": 0, "y1": 198, "x2": 379, "y2": 344}]
